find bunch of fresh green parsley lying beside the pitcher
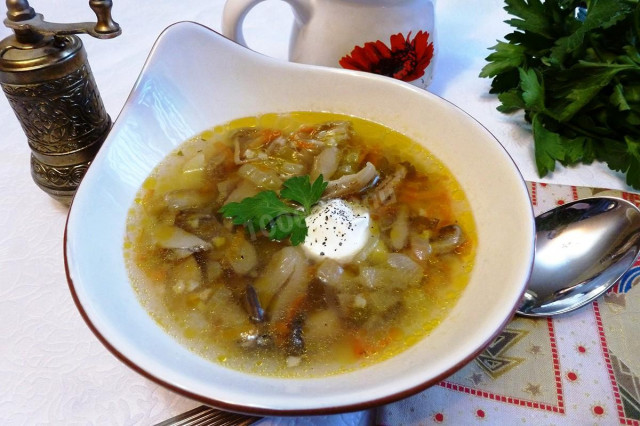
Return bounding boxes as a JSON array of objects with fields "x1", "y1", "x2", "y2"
[{"x1": 480, "y1": 0, "x2": 640, "y2": 189}]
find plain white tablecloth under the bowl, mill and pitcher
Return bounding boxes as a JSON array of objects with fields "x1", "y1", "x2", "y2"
[{"x1": 0, "y1": 0, "x2": 628, "y2": 425}]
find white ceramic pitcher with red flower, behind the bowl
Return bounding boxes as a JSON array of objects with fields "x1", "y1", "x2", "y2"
[{"x1": 222, "y1": 0, "x2": 436, "y2": 88}]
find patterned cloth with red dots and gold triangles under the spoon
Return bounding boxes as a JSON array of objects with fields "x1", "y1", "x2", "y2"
[{"x1": 376, "y1": 183, "x2": 640, "y2": 425}]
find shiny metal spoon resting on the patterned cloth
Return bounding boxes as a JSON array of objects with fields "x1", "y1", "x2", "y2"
[{"x1": 516, "y1": 197, "x2": 640, "y2": 317}]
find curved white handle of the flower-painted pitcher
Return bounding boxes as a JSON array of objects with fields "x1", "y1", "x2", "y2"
[{"x1": 222, "y1": 0, "x2": 311, "y2": 47}]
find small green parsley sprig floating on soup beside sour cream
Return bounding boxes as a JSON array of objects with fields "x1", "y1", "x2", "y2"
[{"x1": 218, "y1": 175, "x2": 328, "y2": 246}]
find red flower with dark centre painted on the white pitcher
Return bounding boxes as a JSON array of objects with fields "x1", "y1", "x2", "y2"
[{"x1": 339, "y1": 31, "x2": 433, "y2": 81}]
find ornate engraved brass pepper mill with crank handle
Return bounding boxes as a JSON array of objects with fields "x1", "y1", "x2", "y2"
[{"x1": 0, "y1": 0, "x2": 121, "y2": 204}]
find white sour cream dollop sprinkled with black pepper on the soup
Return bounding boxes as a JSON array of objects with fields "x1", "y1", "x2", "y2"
[{"x1": 302, "y1": 198, "x2": 370, "y2": 263}]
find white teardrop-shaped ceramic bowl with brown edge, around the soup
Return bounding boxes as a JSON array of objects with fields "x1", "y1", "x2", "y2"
[{"x1": 64, "y1": 23, "x2": 534, "y2": 415}]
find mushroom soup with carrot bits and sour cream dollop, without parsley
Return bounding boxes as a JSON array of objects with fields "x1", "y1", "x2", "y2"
[{"x1": 125, "y1": 112, "x2": 476, "y2": 377}]
